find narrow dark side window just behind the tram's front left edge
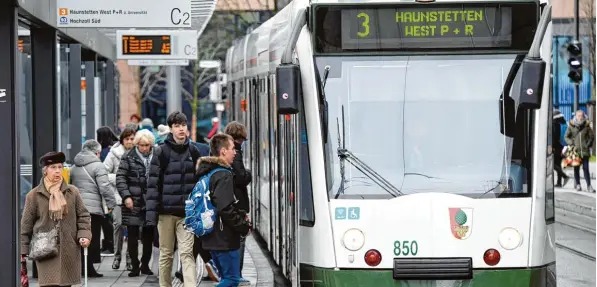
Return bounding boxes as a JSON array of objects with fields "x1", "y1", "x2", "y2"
[{"x1": 299, "y1": 104, "x2": 315, "y2": 226}]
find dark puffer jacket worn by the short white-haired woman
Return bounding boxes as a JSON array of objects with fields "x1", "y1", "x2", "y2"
[{"x1": 116, "y1": 148, "x2": 147, "y2": 226}]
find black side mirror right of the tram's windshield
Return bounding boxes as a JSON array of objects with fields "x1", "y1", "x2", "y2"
[{"x1": 518, "y1": 57, "x2": 545, "y2": 110}]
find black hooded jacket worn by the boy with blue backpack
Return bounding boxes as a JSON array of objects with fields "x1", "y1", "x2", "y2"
[{"x1": 197, "y1": 156, "x2": 249, "y2": 250}]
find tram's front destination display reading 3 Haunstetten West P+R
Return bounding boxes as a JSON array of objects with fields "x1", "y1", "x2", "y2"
[{"x1": 315, "y1": 3, "x2": 538, "y2": 51}]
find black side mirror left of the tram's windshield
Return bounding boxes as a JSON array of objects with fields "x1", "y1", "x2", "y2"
[{"x1": 276, "y1": 64, "x2": 301, "y2": 115}]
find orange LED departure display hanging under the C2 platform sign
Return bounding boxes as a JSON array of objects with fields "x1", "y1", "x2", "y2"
[{"x1": 122, "y1": 35, "x2": 172, "y2": 55}]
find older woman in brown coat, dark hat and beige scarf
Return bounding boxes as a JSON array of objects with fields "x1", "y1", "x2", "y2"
[{"x1": 21, "y1": 152, "x2": 91, "y2": 286}]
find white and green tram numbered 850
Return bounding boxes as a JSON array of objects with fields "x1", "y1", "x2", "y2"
[{"x1": 226, "y1": 0, "x2": 556, "y2": 287}]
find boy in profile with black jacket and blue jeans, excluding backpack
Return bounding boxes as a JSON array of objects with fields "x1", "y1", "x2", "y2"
[{"x1": 194, "y1": 134, "x2": 251, "y2": 287}]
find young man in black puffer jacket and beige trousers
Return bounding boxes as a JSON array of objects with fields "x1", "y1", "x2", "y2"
[{"x1": 146, "y1": 111, "x2": 200, "y2": 287}]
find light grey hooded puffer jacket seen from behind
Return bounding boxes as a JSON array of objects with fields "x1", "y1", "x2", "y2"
[{"x1": 70, "y1": 151, "x2": 116, "y2": 215}]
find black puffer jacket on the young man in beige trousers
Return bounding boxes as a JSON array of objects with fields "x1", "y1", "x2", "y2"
[{"x1": 146, "y1": 134, "x2": 199, "y2": 226}]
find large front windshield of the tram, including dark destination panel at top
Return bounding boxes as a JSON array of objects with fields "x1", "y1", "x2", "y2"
[{"x1": 315, "y1": 2, "x2": 536, "y2": 199}]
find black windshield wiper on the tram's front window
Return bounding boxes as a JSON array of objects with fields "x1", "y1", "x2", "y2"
[{"x1": 335, "y1": 105, "x2": 403, "y2": 198}]
